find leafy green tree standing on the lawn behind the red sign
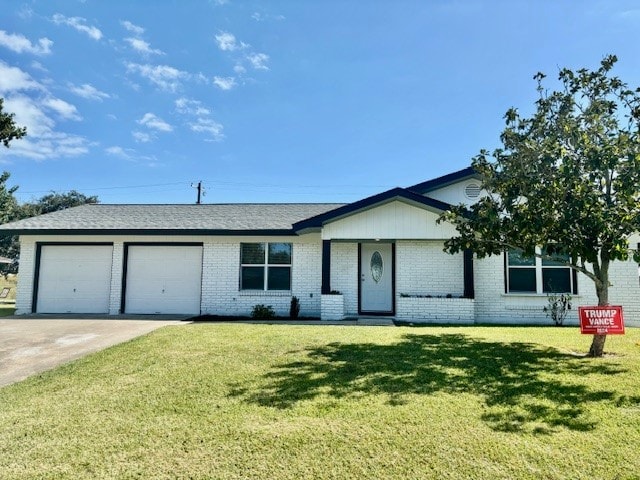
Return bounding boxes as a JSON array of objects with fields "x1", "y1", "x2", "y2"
[{"x1": 440, "y1": 55, "x2": 640, "y2": 357}]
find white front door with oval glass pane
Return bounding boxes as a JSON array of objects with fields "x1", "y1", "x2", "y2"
[{"x1": 360, "y1": 242, "x2": 393, "y2": 315}]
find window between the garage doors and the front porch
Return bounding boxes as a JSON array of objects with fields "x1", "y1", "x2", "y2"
[{"x1": 240, "y1": 243, "x2": 291, "y2": 290}]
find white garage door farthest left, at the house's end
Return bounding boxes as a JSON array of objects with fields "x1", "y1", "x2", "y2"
[{"x1": 36, "y1": 245, "x2": 113, "y2": 313}]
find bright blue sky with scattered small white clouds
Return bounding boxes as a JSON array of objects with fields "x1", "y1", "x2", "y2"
[{"x1": 0, "y1": 0, "x2": 640, "y2": 203}]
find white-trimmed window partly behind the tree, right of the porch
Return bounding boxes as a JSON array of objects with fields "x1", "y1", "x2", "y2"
[{"x1": 505, "y1": 250, "x2": 578, "y2": 294}]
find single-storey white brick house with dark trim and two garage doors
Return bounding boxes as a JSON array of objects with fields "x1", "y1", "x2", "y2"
[{"x1": 0, "y1": 168, "x2": 640, "y2": 326}]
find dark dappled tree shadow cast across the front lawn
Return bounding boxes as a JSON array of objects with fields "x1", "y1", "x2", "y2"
[{"x1": 231, "y1": 334, "x2": 624, "y2": 433}]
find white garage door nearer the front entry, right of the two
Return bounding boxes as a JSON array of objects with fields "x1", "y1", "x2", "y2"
[{"x1": 125, "y1": 245, "x2": 202, "y2": 315}]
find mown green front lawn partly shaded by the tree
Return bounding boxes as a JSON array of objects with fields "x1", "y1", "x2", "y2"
[{"x1": 0, "y1": 323, "x2": 640, "y2": 480}]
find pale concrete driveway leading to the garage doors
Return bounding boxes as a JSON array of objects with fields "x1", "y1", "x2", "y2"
[{"x1": 0, "y1": 317, "x2": 184, "y2": 387}]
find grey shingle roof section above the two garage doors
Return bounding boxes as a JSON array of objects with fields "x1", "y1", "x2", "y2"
[{"x1": 0, "y1": 203, "x2": 343, "y2": 235}]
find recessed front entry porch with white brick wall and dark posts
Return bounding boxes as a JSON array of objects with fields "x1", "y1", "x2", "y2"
[{"x1": 321, "y1": 239, "x2": 475, "y2": 323}]
